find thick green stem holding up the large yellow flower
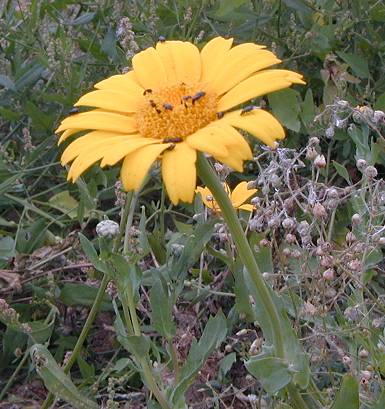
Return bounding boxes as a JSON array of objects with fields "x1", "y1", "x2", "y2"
[{"x1": 197, "y1": 153, "x2": 308, "y2": 409}]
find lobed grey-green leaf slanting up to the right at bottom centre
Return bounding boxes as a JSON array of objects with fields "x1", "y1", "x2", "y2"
[{"x1": 170, "y1": 311, "x2": 227, "y2": 404}]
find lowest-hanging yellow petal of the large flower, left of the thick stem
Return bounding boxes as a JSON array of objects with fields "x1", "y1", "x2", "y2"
[{"x1": 162, "y1": 142, "x2": 197, "y2": 205}]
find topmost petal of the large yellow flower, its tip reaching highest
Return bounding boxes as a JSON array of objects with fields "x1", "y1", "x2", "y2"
[{"x1": 201, "y1": 37, "x2": 233, "y2": 83}]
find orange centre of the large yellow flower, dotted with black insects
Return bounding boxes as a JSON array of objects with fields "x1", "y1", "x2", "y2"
[{"x1": 136, "y1": 83, "x2": 218, "y2": 142}]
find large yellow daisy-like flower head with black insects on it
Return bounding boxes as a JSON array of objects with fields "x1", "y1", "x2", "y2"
[{"x1": 56, "y1": 37, "x2": 304, "y2": 204}]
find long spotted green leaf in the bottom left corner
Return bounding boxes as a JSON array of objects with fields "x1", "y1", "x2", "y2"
[{"x1": 30, "y1": 344, "x2": 99, "y2": 409}]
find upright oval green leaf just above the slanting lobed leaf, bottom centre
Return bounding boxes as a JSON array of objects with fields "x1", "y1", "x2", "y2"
[{"x1": 150, "y1": 278, "x2": 175, "y2": 339}]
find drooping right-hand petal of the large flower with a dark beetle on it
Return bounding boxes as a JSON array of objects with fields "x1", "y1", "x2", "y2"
[{"x1": 218, "y1": 109, "x2": 285, "y2": 148}]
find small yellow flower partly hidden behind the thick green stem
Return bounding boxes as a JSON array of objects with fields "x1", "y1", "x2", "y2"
[{"x1": 196, "y1": 182, "x2": 257, "y2": 212}]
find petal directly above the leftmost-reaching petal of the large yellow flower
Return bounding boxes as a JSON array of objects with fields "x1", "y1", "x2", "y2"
[{"x1": 75, "y1": 90, "x2": 144, "y2": 113}]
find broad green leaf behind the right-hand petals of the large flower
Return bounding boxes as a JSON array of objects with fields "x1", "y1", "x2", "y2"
[{"x1": 268, "y1": 88, "x2": 301, "y2": 132}]
